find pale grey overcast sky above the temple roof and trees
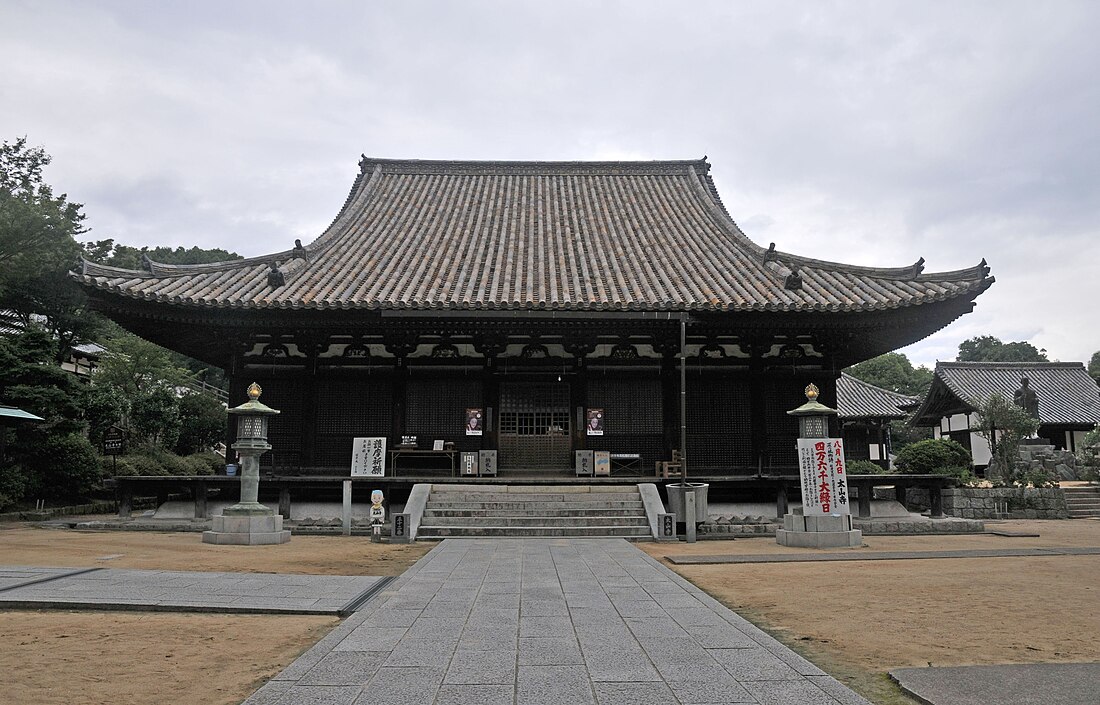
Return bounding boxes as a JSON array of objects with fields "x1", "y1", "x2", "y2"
[{"x1": 0, "y1": 0, "x2": 1100, "y2": 365}]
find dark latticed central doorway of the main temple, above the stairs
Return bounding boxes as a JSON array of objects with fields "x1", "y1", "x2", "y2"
[{"x1": 499, "y1": 382, "x2": 572, "y2": 470}]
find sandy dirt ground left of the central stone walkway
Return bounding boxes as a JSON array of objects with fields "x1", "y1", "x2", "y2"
[{"x1": 0, "y1": 525, "x2": 432, "y2": 705}]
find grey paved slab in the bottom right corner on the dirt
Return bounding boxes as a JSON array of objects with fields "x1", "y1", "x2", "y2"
[{"x1": 890, "y1": 663, "x2": 1100, "y2": 705}]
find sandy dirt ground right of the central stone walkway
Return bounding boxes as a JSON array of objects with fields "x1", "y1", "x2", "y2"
[{"x1": 638, "y1": 520, "x2": 1100, "y2": 704}]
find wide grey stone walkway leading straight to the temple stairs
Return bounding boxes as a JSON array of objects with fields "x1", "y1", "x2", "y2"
[{"x1": 246, "y1": 539, "x2": 868, "y2": 705}]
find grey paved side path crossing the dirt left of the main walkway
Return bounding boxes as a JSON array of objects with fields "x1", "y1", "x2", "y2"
[{"x1": 0, "y1": 566, "x2": 384, "y2": 615}]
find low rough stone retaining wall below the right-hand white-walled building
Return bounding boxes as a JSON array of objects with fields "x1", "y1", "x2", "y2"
[{"x1": 876, "y1": 487, "x2": 1069, "y2": 519}]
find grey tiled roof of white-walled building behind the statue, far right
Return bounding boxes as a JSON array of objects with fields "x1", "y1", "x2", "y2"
[{"x1": 915, "y1": 362, "x2": 1100, "y2": 425}]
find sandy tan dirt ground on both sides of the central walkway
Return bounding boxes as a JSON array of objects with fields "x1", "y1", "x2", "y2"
[{"x1": 0, "y1": 520, "x2": 1100, "y2": 705}]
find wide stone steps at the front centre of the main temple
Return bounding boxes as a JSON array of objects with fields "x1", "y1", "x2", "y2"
[{"x1": 417, "y1": 484, "x2": 652, "y2": 539}]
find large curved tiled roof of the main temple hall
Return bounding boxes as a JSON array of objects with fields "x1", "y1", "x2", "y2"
[{"x1": 76, "y1": 157, "x2": 993, "y2": 311}]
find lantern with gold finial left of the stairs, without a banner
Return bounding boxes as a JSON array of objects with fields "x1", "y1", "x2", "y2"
[{"x1": 202, "y1": 382, "x2": 290, "y2": 546}]
